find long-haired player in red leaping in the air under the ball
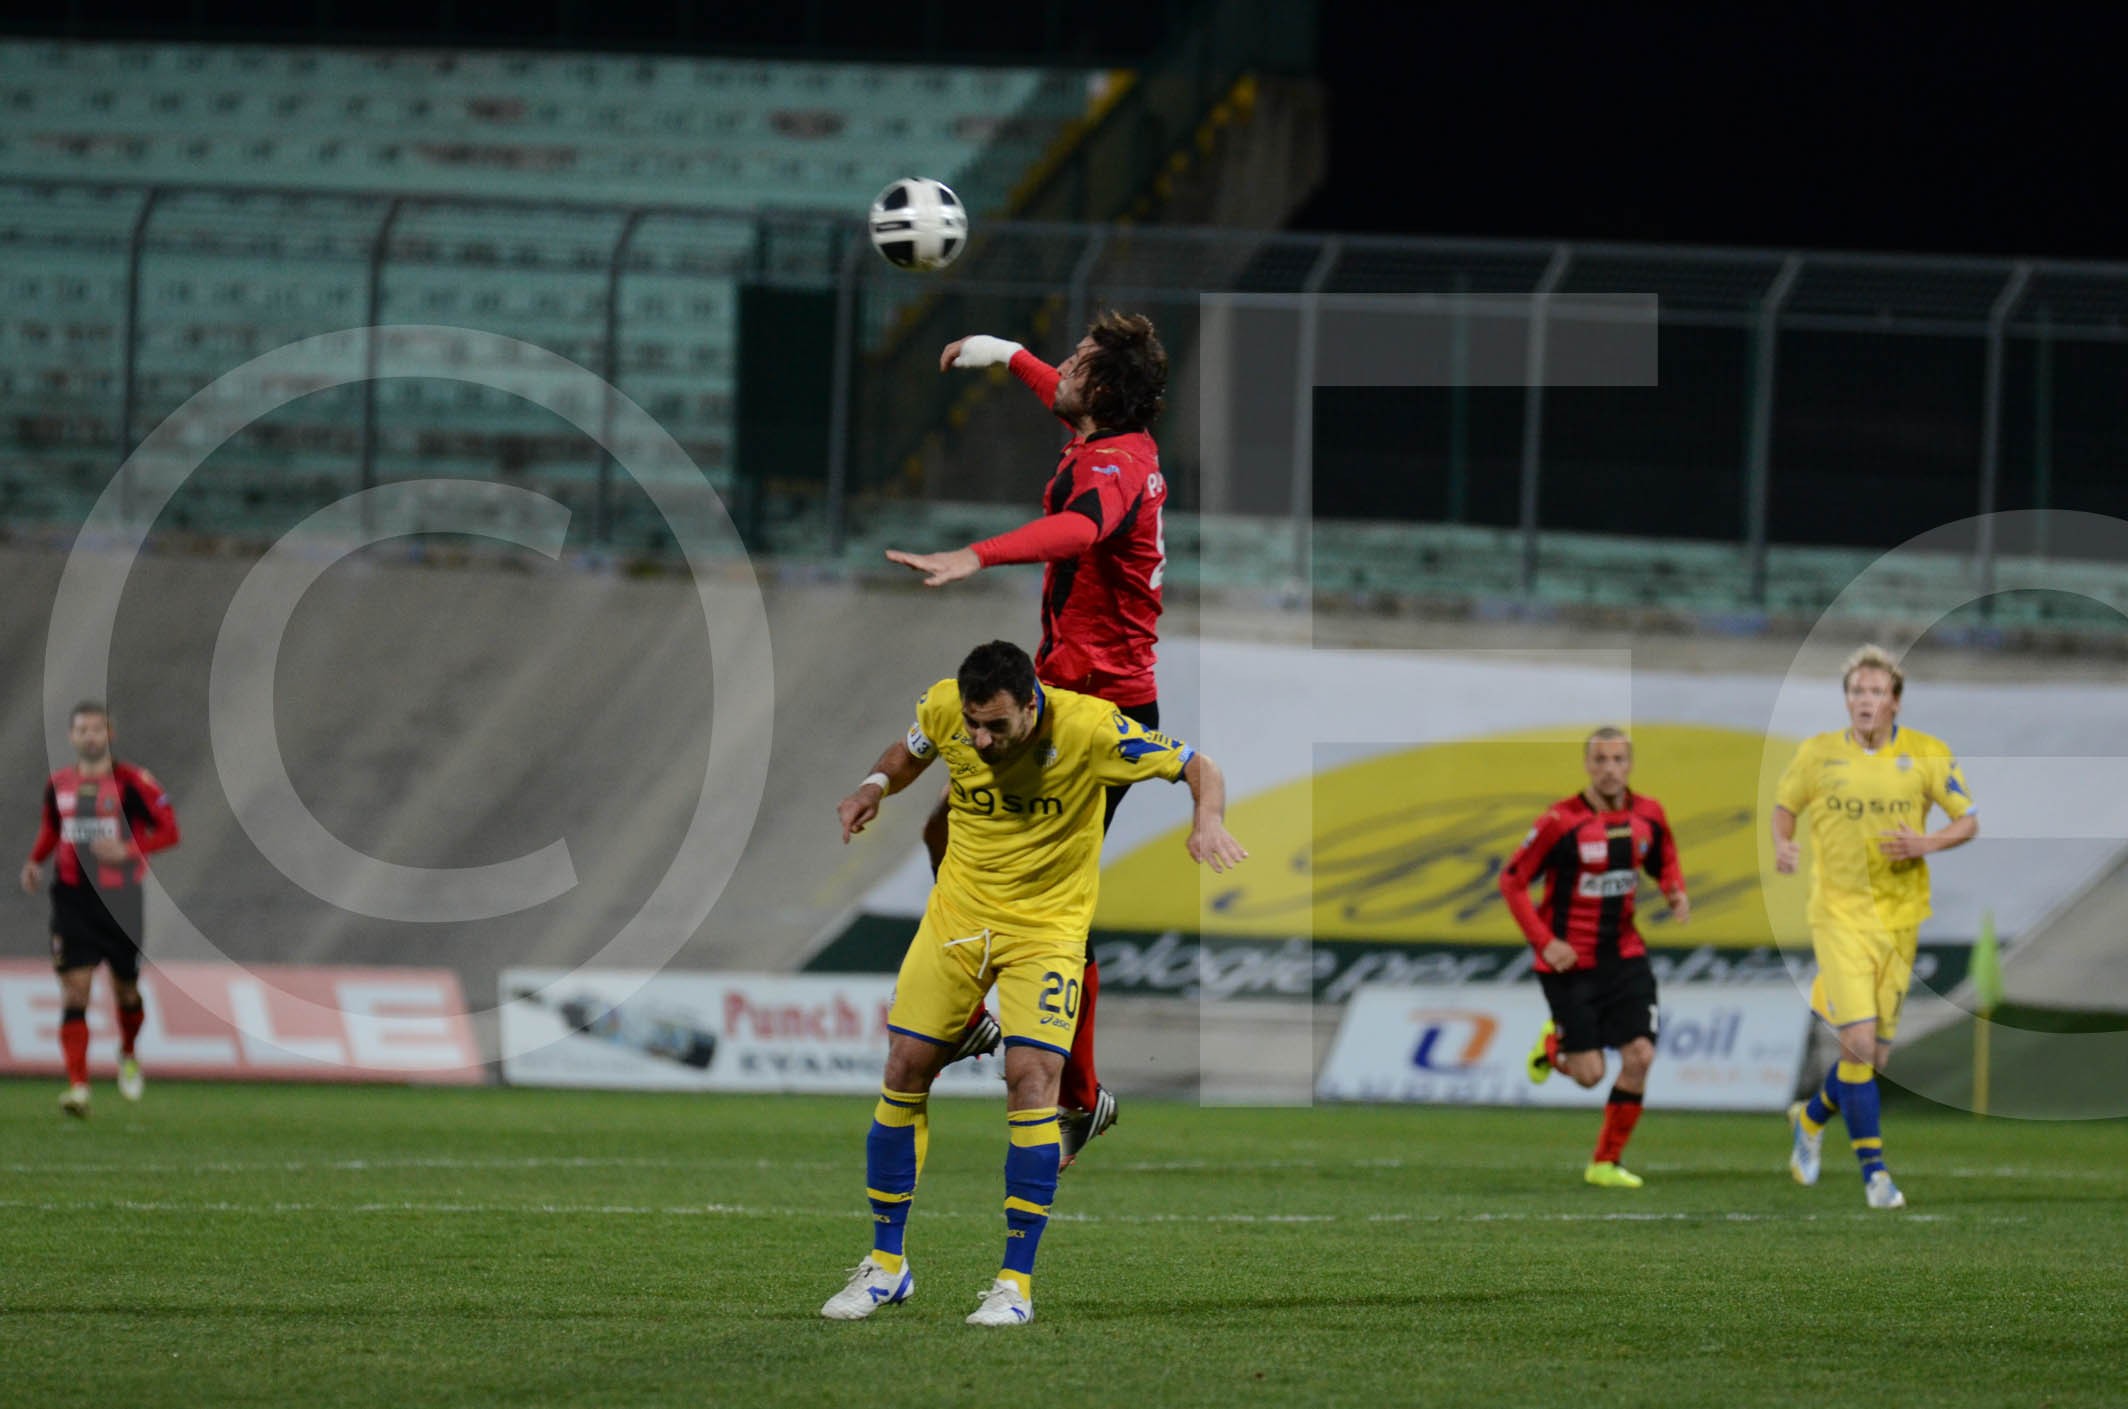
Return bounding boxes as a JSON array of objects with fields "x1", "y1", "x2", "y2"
[{"x1": 887, "y1": 311, "x2": 1168, "y2": 1166}]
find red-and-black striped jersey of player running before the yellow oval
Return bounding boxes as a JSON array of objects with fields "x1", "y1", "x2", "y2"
[{"x1": 1500, "y1": 792, "x2": 1685, "y2": 973}]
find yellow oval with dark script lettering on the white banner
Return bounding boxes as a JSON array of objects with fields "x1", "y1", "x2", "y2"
[{"x1": 1094, "y1": 724, "x2": 1809, "y2": 945}]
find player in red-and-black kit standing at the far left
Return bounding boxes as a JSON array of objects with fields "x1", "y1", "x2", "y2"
[{"x1": 21, "y1": 700, "x2": 177, "y2": 1115}]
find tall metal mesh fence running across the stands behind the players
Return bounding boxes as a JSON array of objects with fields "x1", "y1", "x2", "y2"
[{"x1": 0, "y1": 173, "x2": 2128, "y2": 604}]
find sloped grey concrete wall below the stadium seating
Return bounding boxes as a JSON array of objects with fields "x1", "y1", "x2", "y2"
[{"x1": 0, "y1": 545, "x2": 2124, "y2": 1096}]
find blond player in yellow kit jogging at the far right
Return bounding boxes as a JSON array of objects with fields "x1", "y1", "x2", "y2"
[{"x1": 1773, "y1": 645, "x2": 1981, "y2": 1209}]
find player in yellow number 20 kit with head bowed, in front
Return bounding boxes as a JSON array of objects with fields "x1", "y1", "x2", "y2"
[{"x1": 819, "y1": 641, "x2": 1247, "y2": 1326}]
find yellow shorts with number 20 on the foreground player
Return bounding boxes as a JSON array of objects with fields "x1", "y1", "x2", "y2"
[{"x1": 887, "y1": 892, "x2": 1085, "y2": 1056}]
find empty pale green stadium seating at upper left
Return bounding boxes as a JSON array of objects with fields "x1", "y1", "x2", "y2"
[{"x1": 0, "y1": 43, "x2": 1087, "y2": 543}]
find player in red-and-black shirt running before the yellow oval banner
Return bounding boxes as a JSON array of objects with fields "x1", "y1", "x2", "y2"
[{"x1": 1500, "y1": 728, "x2": 1692, "y2": 1190}]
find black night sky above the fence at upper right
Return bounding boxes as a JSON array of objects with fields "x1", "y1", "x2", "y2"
[{"x1": 1298, "y1": 4, "x2": 2128, "y2": 260}]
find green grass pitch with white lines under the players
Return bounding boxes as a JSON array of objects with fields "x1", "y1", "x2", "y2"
[{"x1": 0, "y1": 1081, "x2": 2128, "y2": 1409}]
